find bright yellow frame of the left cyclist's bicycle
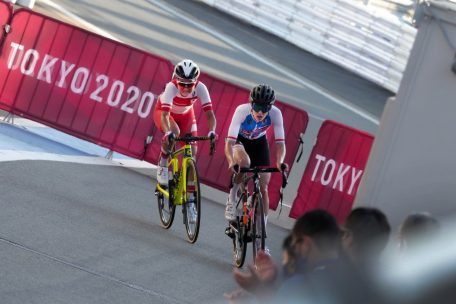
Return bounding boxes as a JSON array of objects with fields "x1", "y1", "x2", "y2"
[{"x1": 157, "y1": 143, "x2": 193, "y2": 205}]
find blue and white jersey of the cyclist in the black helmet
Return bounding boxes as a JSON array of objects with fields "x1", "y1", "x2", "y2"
[{"x1": 227, "y1": 103, "x2": 285, "y2": 142}]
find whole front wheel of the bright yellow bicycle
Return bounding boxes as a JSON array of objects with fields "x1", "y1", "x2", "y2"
[{"x1": 183, "y1": 159, "x2": 201, "y2": 244}]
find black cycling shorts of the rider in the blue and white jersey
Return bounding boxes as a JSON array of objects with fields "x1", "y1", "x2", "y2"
[{"x1": 236, "y1": 135, "x2": 271, "y2": 168}]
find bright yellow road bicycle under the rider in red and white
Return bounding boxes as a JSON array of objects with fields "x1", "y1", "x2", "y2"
[{"x1": 155, "y1": 136, "x2": 215, "y2": 244}]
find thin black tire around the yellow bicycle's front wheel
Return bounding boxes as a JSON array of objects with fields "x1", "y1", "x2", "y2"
[{"x1": 183, "y1": 159, "x2": 201, "y2": 244}]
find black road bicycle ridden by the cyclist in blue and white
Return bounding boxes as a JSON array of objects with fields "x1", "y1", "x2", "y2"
[{"x1": 225, "y1": 164, "x2": 287, "y2": 268}]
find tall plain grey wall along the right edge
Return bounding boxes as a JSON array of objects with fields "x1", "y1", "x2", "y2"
[{"x1": 355, "y1": 1, "x2": 456, "y2": 225}]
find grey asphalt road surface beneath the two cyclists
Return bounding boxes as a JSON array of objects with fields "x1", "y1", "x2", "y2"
[{"x1": 0, "y1": 161, "x2": 287, "y2": 304}]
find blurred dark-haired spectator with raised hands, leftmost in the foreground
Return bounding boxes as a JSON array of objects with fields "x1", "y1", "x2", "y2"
[{"x1": 224, "y1": 209, "x2": 341, "y2": 303}]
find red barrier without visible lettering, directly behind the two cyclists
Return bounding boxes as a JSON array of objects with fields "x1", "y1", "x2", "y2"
[{"x1": 195, "y1": 75, "x2": 308, "y2": 209}]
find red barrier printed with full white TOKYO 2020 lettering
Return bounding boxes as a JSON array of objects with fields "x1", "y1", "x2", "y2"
[{"x1": 0, "y1": 10, "x2": 172, "y2": 159}]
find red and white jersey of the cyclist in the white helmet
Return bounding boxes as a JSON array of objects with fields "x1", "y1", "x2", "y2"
[{"x1": 158, "y1": 79, "x2": 212, "y2": 114}]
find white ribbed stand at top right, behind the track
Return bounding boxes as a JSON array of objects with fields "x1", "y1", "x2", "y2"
[{"x1": 202, "y1": 0, "x2": 416, "y2": 92}]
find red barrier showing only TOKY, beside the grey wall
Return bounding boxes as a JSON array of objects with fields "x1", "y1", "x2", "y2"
[{"x1": 290, "y1": 121, "x2": 374, "y2": 222}]
